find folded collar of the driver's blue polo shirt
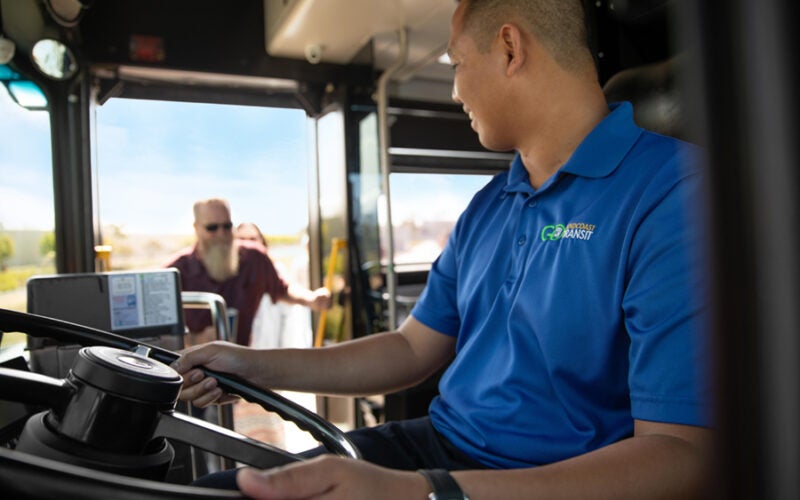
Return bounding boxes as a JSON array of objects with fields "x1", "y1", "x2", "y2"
[{"x1": 505, "y1": 101, "x2": 642, "y2": 192}]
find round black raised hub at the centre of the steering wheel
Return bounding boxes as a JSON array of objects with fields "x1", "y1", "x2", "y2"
[{"x1": 17, "y1": 346, "x2": 183, "y2": 479}]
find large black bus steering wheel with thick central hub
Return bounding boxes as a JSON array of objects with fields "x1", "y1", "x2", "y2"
[{"x1": 0, "y1": 309, "x2": 360, "y2": 499}]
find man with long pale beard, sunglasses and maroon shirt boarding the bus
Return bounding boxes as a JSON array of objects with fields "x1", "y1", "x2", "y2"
[{"x1": 165, "y1": 198, "x2": 331, "y2": 345}]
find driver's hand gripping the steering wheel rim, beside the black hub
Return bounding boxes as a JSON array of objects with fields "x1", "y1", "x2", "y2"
[{"x1": 171, "y1": 341, "x2": 246, "y2": 408}]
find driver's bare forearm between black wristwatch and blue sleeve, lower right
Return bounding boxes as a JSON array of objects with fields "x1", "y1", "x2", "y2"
[{"x1": 453, "y1": 420, "x2": 713, "y2": 500}]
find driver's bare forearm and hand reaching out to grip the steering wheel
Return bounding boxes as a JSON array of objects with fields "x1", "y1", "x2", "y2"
[{"x1": 173, "y1": 317, "x2": 455, "y2": 407}]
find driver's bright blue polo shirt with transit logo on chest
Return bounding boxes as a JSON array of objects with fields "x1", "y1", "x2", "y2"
[{"x1": 412, "y1": 103, "x2": 710, "y2": 468}]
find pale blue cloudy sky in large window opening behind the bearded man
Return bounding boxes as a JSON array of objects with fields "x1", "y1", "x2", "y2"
[{"x1": 91, "y1": 99, "x2": 308, "y2": 234}]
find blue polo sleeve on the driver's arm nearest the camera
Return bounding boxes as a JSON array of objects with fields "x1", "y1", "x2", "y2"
[{"x1": 622, "y1": 158, "x2": 712, "y2": 426}]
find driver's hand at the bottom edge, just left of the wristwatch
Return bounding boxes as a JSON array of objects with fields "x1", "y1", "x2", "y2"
[{"x1": 236, "y1": 455, "x2": 430, "y2": 500}]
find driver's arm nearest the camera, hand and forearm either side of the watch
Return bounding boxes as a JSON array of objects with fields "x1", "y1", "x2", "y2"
[{"x1": 237, "y1": 420, "x2": 712, "y2": 500}]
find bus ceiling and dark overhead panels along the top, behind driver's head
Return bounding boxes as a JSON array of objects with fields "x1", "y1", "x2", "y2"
[{"x1": 0, "y1": 0, "x2": 674, "y2": 116}]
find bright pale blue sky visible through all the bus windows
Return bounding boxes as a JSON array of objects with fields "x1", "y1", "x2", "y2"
[{"x1": 0, "y1": 87, "x2": 488, "y2": 235}]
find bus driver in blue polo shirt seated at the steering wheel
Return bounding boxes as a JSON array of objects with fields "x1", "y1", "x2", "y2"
[{"x1": 175, "y1": 0, "x2": 712, "y2": 500}]
